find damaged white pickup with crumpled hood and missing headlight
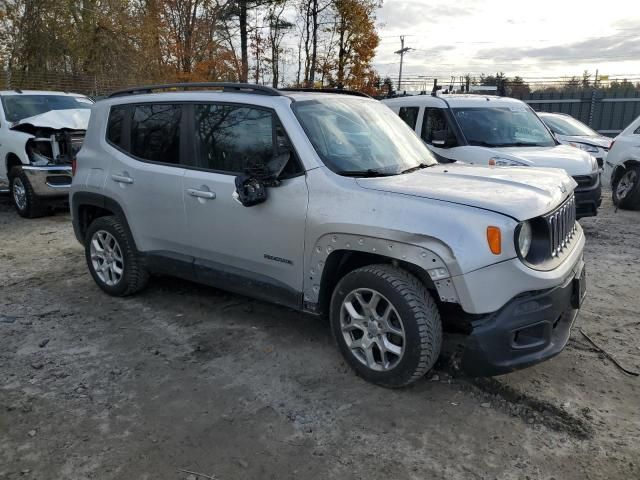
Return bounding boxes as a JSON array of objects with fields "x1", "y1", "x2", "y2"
[{"x1": 0, "y1": 90, "x2": 93, "y2": 218}]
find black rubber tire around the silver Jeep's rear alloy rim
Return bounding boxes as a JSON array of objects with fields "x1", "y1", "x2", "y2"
[{"x1": 84, "y1": 216, "x2": 149, "y2": 297}]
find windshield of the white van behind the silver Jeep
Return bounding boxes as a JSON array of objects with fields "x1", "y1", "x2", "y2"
[{"x1": 453, "y1": 105, "x2": 556, "y2": 147}]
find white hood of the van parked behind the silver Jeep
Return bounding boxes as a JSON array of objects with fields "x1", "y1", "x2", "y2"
[{"x1": 490, "y1": 145, "x2": 592, "y2": 176}]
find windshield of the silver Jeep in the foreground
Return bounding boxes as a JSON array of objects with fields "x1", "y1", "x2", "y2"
[{"x1": 293, "y1": 95, "x2": 437, "y2": 175}]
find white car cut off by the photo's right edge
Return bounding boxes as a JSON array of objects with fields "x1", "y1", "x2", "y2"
[{"x1": 603, "y1": 117, "x2": 640, "y2": 210}]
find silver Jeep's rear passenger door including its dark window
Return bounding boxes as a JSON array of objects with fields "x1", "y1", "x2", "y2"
[{"x1": 106, "y1": 103, "x2": 188, "y2": 261}]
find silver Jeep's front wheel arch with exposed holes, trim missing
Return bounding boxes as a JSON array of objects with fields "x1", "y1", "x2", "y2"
[{"x1": 304, "y1": 233, "x2": 459, "y2": 313}]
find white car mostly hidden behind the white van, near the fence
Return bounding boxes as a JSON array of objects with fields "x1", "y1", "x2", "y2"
[{"x1": 538, "y1": 112, "x2": 612, "y2": 168}]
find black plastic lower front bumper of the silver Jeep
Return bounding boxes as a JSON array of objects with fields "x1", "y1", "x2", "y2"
[{"x1": 461, "y1": 262, "x2": 586, "y2": 376}]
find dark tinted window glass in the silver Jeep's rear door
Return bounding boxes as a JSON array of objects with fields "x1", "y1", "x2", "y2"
[{"x1": 131, "y1": 105, "x2": 182, "y2": 163}]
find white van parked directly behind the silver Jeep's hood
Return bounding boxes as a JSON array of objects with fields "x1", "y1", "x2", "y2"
[{"x1": 383, "y1": 95, "x2": 602, "y2": 218}]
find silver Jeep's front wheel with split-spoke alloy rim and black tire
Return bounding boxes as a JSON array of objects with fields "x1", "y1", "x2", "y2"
[{"x1": 330, "y1": 265, "x2": 442, "y2": 388}]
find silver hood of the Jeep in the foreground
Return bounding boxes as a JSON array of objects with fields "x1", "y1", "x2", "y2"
[{"x1": 357, "y1": 162, "x2": 577, "y2": 220}]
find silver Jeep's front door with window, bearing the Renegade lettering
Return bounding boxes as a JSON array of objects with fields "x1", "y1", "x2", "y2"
[{"x1": 183, "y1": 103, "x2": 308, "y2": 306}]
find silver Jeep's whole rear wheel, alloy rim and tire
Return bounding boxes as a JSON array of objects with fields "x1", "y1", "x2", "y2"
[{"x1": 85, "y1": 217, "x2": 149, "y2": 297}]
